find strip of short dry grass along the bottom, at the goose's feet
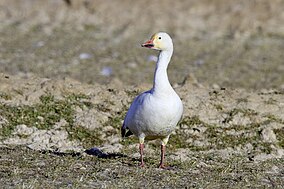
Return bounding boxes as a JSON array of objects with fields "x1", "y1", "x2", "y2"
[{"x1": 0, "y1": 147, "x2": 284, "y2": 188}]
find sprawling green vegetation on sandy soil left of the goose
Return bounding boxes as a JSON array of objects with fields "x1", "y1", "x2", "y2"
[{"x1": 0, "y1": 91, "x2": 131, "y2": 147}]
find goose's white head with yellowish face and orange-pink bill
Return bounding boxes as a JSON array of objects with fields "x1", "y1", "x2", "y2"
[{"x1": 141, "y1": 32, "x2": 173, "y2": 51}]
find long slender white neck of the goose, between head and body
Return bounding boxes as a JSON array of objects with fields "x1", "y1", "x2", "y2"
[{"x1": 152, "y1": 49, "x2": 173, "y2": 94}]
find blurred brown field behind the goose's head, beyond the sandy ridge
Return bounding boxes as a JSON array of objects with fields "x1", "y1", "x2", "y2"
[{"x1": 0, "y1": 0, "x2": 284, "y2": 90}]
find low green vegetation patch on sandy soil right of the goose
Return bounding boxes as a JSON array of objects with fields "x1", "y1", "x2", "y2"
[{"x1": 170, "y1": 113, "x2": 276, "y2": 153}]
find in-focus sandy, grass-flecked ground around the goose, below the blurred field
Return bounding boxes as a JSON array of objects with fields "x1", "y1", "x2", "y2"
[{"x1": 0, "y1": 74, "x2": 284, "y2": 188}]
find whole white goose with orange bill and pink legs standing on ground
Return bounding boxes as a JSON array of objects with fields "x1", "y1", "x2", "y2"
[{"x1": 121, "y1": 32, "x2": 183, "y2": 168}]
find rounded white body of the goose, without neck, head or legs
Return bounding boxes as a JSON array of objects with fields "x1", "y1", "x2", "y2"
[{"x1": 124, "y1": 86, "x2": 182, "y2": 140}]
